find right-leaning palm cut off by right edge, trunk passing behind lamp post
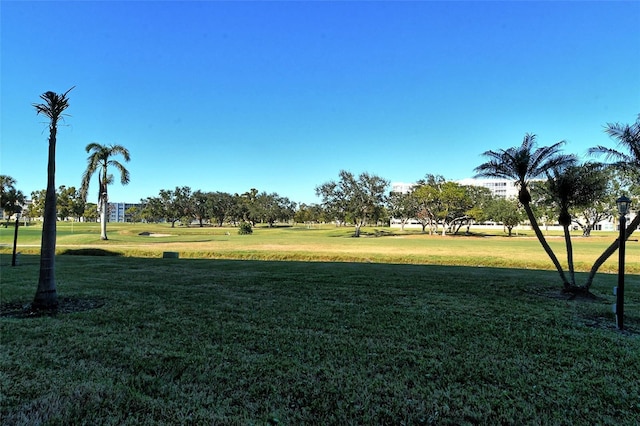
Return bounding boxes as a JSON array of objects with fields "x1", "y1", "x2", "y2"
[{"x1": 584, "y1": 114, "x2": 640, "y2": 289}]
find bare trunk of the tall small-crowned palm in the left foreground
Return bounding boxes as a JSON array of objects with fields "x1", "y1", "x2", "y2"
[{"x1": 32, "y1": 124, "x2": 58, "y2": 309}]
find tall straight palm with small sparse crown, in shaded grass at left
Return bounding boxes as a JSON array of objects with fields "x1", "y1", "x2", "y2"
[{"x1": 32, "y1": 87, "x2": 73, "y2": 309}]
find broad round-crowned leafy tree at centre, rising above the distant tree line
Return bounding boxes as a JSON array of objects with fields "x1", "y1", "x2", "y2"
[{"x1": 316, "y1": 170, "x2": 389, "y2": 237}]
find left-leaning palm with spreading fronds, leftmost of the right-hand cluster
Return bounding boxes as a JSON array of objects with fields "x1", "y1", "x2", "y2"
[{"x1": 475, "y1": 133, "x2": 576, "y2": 288}]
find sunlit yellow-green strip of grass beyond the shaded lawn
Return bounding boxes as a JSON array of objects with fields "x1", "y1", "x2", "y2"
[{"x1": 0, "y1": 222, "x2": 640, "y2": 274}]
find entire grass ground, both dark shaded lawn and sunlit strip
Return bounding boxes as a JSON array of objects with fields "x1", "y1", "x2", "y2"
[{"x1": 0, "y1": 224, "x2": 640, "y2": 425}]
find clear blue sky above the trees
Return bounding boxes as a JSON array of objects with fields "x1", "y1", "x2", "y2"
[{"x1": 0, "y1": 0, "x2": 640, "y2": 203}]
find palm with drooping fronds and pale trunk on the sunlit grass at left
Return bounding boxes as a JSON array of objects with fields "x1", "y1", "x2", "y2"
[{"x1": 80, "y1": 142, "x2": 130, "y2": 240}]
